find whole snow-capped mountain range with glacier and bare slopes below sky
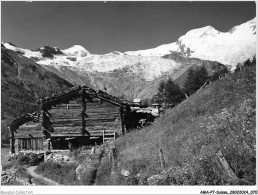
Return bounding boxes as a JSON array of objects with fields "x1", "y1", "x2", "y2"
[{"x1": 2, "y1": 18, "x2": 256, "y2": 98}]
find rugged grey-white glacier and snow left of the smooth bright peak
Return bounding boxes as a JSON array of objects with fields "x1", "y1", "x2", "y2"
[{"x1": 3, "y1": 43, "x2": 179, "y2": 81}]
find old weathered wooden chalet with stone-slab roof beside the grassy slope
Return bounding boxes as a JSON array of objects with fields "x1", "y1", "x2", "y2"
[{"x1": 9, "y1": 86, "x2": 132, "y2": 153}]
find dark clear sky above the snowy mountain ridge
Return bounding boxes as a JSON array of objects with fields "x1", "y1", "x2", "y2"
[{"x1": 1, "y1": 1, "x2": 256, "y2": 54}]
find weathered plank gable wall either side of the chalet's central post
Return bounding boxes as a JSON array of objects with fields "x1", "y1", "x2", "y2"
[{"x1": 49, "y1": 99, "x2": 121, "y2": 136}]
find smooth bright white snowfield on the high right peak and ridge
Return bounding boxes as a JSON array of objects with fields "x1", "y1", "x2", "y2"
[{"x1": 125, "y1": 17, "x2": 256, "y2": 66}]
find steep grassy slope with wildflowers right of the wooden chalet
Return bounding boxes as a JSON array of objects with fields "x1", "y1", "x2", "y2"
[{"x1": 98, "y1": 66, "x2": 256, "y2": 185}]
